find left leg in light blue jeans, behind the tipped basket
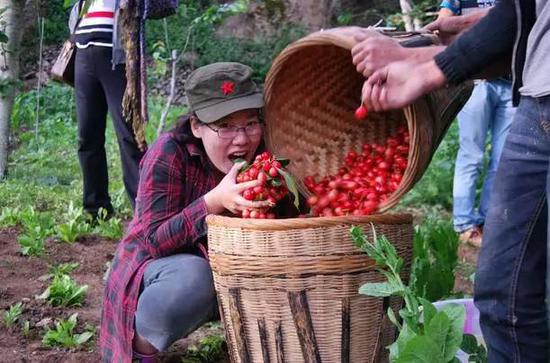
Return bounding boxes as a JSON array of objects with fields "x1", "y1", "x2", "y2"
[{"x1": 453, "y1": 81, "x2": 494, "y2": 237}]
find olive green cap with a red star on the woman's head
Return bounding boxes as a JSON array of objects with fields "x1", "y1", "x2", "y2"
[{"x1": 185, "y1": 62, "x2": 264, "y2": 123}]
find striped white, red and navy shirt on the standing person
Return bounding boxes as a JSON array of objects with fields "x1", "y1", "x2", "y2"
[{"x1": 74, "y1": 0, "x2": 115, "y2": 48}]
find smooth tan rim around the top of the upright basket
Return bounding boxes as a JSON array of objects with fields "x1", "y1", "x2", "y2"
[{"x1": 206, "y1": 213, "x2": 413, "y2": 231}]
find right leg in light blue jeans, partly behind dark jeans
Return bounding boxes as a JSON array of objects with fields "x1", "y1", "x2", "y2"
[{"x1": 477, "y1": 79, "x2": 516, "y2": 226}]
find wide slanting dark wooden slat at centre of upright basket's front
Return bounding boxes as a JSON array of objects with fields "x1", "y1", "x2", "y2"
[{"x1": 288, "y1": 291, "x2": 321, "y2": 363}]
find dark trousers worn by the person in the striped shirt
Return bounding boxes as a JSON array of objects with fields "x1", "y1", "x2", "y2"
[{"x1": 75, "y1": 46, "x2": 143, "y2": 215}]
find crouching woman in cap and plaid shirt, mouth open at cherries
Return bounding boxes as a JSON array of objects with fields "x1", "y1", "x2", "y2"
[{"x1": 100, "y1": 63, "x2": 297, "y2": 362}]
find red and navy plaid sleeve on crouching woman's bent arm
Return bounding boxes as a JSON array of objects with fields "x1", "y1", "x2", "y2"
[{"x1": 136, "y1": 136, "x2": 207, "y2": 258}]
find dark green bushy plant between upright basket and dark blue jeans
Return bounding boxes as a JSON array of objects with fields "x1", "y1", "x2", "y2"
[{"x1": 411, "y1": 217, "x2": 458, "y2": 301}]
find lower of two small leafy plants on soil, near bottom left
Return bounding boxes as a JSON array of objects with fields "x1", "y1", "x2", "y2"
[{"x1": 42, "y1": 313, "x2": 95, "y2": 348}]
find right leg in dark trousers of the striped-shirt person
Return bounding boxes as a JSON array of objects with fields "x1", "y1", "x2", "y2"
[{"x1": 98, "y1": 48, "x2": 144, "y2": 209}]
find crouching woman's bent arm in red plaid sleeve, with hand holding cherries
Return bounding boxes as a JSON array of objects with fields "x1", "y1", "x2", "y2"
[{"x1": 136, "y1": 140, "x2": 268, "y2": 258}]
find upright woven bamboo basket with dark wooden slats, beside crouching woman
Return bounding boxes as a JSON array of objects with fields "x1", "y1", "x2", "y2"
[{"x1": 206, "y1": 215, "x2": 413, "y2": 363}]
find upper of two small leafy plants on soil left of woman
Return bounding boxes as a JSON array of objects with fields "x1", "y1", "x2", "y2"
[{"x1": 38, "y1": 275, "x2": 88, "y2": 307}]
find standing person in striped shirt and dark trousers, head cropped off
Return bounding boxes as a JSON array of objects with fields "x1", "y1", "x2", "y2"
[{"x1": 69, "y1": 0, "x2": 144, "y2": 218}]
